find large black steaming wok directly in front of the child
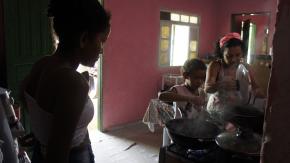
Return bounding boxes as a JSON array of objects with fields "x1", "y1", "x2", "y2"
[{"x1": 165, "y1": 118, "x2": 221, "y2": 149}]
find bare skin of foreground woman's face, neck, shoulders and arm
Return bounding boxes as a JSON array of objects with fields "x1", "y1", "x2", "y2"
[{"x1": 22, "y1": 30, "x2": 109, "y2": 163}]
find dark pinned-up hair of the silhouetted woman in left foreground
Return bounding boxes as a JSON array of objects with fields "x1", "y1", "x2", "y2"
[{"x1": 48, "y1": 0, "x2": 111, "y2": 48}]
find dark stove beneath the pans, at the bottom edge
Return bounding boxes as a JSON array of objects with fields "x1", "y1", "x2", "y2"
[{"x1": 159, "y1": 143, "x2": 260, "y2": 163}]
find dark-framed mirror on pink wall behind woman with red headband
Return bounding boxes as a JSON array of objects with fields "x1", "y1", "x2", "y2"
[{"x1": 231, "y1": 12, "x2": 270, "y2": 63}]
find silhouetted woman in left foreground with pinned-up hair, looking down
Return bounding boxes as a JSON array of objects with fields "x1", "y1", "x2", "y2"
[{"x1": 23, "y1": 0, "x2": 110, "y2": 163}]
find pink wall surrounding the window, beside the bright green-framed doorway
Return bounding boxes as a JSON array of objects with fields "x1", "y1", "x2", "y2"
[{"x1": 103, "y1": 0, "x2": 216, "y2": 129}]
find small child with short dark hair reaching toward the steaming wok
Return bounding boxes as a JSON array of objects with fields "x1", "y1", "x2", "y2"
[{"x1": 158, "y1": 59, "x2": 206, "y2": 118}]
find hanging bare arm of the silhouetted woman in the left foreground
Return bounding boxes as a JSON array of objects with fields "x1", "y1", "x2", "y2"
[{"x1": 45, "y1": 69, "x2": 89, "y2": 163}]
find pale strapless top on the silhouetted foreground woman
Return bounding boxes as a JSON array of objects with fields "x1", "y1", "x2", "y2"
[{"x1": 25, "y1": 92, "x2": 94, "y2": 147}]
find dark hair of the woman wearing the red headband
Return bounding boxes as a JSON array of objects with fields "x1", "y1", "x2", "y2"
[{"x1": 215, "y1": 38, "x2": 245, "y2": 59}]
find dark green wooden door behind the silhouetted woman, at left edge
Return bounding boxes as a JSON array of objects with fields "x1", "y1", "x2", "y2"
[{"x1": 3, "y1": 0, "x2": 53, "y2": 131}]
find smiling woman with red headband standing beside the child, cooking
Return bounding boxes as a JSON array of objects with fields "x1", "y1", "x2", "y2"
[{"x1": 205, "y1": 33, "x2": 264, "y2": 124}]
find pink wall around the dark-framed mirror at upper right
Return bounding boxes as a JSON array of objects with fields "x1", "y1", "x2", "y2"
[{"x1": 217, "y1": 0, "x2": 277, "y2": 52}]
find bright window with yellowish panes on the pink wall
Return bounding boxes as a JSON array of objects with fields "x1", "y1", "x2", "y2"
[{"x1": 159, "y1": 11, "x2": 199, "y2": 66}]
